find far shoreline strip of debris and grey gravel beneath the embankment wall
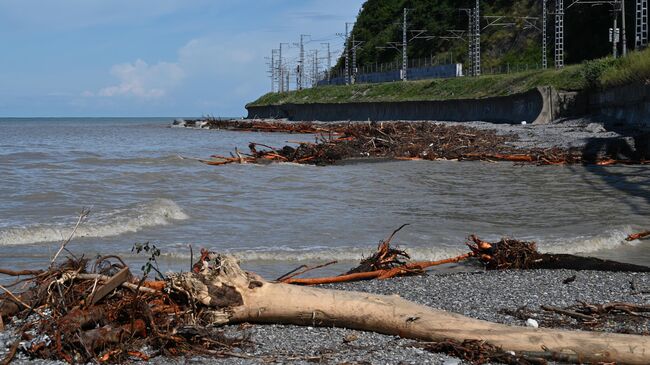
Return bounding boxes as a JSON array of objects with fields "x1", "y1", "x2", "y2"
[{"x1": 172, "y1": 117, "x2": 650, "y2": 165}]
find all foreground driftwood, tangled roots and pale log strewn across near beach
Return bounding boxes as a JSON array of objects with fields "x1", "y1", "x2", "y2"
[{"x1": 0, "y1": 225, "x2": 650, "y2": 365}]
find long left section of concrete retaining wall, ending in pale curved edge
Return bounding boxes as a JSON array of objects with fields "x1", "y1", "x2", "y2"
[{"x1": 246, "y1": 88, "x2": 562, "y2": 124}]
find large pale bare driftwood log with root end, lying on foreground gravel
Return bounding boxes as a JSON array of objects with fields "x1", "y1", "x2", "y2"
[{"x1": 169, "y1": 255, "x2": 650, "y2": 365}]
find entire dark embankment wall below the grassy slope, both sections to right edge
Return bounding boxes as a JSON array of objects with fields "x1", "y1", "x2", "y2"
[{"x1": 246, "y1": 84, "x2": 650, "y2": 130}]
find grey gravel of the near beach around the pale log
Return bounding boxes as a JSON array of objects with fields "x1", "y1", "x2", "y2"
[{"x1": 0, "y1": 270, "x2": 650, "y2": 365}]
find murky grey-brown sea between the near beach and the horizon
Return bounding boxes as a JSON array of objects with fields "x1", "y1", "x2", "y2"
[{"x1": 0, "y1": 117, "x2": 650, "y2": 279}]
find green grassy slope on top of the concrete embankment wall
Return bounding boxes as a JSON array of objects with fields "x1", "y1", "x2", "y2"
[{"x1": 249, "y1": 49, "x2": 650, "y2": 106}]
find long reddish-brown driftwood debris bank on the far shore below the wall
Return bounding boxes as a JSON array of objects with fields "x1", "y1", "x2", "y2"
[{"x1": 201, "y1": 121, "x2": 644, "y2": 165}]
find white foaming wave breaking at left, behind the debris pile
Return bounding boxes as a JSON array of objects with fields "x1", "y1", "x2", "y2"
[{"x1": 0, "y1": 199, "x2": 189, "y2": 246}]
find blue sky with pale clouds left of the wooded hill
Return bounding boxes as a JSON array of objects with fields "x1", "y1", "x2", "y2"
[{"x1": 0, "y1": 0, "x2": 364, "y2": 117}]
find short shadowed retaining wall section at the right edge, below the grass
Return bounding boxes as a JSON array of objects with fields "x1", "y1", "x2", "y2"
[{"x1": 588, "y1": 84, "x2": 650, "y2": 130}]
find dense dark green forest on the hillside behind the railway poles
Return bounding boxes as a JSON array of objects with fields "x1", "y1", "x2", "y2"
[{"x1": 336, "y1": 0, "x2": 635, "y2": 69}]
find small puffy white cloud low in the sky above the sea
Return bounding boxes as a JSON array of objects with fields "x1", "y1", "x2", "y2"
[{"x1": 91, "y1": 59, "x2": 185, "y2": 99}]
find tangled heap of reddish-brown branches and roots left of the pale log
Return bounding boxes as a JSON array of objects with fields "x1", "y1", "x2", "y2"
[{"x1": 0, "y1": 256, "x2": 246, "y2": 363}]
